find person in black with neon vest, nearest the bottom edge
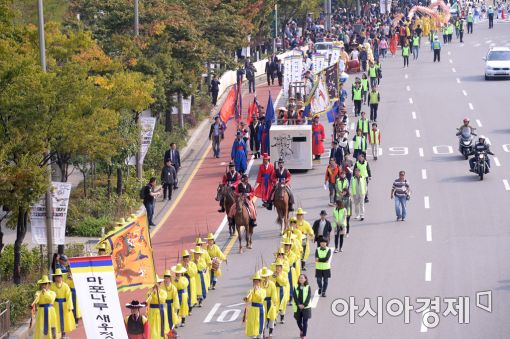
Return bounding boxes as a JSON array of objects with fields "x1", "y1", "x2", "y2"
[{"x1": 292, "y1": 274, "x2": 312, "y2": 339}]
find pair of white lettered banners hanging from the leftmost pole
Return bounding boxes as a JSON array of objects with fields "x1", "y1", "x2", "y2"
[{"x1": 30, "y1": 182, "x2": 71, "y2": 245}]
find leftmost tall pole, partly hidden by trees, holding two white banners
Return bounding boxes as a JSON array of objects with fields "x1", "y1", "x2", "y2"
[{"x1": 37, "y1": 0, "x2": 53, "y2": 273}]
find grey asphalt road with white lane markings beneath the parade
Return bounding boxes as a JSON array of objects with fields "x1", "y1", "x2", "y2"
[{"x1": 179, "y1": 24, "x2": 510, "y2": 339}]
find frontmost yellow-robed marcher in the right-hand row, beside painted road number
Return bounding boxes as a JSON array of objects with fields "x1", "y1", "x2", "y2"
[{"x1": 243, "y1": 272, "x2": 266, "y2": 339}]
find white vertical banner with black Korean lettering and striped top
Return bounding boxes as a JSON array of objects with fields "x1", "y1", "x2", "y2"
[{"x1": 69, "y1": 256, "x2": 128, "y2": 339}]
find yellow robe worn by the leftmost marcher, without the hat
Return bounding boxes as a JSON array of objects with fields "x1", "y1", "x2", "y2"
[{"x1": 34, "y1": 291, "x2": 58, "y2": 339}]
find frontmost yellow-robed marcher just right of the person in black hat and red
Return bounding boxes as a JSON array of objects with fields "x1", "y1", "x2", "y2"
[{"x1": 146, "y1": 276, "x2": 170, "y2": 339}]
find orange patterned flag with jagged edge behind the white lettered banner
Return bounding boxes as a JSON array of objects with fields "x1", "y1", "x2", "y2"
[{"x1": 101, "y1": 214, "x2": 156, "y2": 291}]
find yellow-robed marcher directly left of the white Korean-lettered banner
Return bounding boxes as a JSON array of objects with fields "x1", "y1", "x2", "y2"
[{"x1": 50, "y1": 270, "x2": 76, "y2": 337}]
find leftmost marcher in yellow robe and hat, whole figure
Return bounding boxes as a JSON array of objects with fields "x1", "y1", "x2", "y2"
[{"x1": 32, "y1": 275, "x2": 58, "y2": 339}]
